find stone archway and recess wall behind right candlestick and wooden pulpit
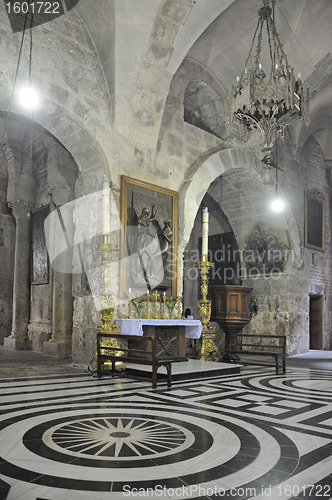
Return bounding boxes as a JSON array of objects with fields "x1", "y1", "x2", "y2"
[{"x1": 180, "y1": 148, "x2": 301, "y2": 348}]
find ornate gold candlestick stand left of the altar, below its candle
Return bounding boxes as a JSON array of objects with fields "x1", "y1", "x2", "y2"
[{"x1": 98, "y1": 235, "x2": 126, "y2": 370}]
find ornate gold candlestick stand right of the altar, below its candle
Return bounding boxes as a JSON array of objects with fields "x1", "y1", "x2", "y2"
[{"x1": 197, "y1": 255, "x2": 220, "y2": 361}]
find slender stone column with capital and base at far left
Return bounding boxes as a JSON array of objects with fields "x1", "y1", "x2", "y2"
[{"x1": 4, "y1": 203, "x2": 30, "y2": 351}]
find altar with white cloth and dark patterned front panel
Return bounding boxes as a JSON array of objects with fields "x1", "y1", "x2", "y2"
[{"x1": 116, "y1": 318, "x2": 203, "y2": 360}]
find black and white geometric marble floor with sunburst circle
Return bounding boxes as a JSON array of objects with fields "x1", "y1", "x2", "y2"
[{"x1": 0, "y1": 367, "x2": 332, "y2": 500}]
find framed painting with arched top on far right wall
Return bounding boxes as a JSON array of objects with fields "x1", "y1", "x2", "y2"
[{"x1": 305, "y1": 189, "x2": 325, "y2": 251}]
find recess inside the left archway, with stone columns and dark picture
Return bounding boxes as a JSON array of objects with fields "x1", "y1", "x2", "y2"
[{"x1": 0, "y1": 114, "x2": 79, "y2": 354}]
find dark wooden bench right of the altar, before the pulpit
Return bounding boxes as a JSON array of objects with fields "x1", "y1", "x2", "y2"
[{"x1": 226, "y1": 333, "x2": 286, "y2": 374}]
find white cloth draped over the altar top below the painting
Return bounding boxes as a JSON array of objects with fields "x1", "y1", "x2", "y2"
[{"x1": 115, "y1": 318, "x2": 203, "y2": 339}]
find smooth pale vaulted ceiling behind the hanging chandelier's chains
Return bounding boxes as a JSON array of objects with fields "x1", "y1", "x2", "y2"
[{"x1": 184, "y1": 0, "x2": 332, "y2": 86}]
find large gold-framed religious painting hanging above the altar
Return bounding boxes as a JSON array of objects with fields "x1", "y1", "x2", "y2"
[{"x1": 120, "y1": 176, "x2": 178, "y2": 297}]
